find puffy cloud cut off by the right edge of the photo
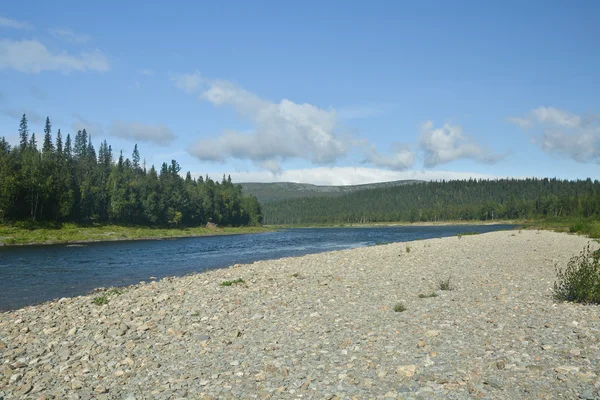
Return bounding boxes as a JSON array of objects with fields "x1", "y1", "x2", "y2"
[{"x1": 507, "y1": 107, "x2": 600, "y2": 163}]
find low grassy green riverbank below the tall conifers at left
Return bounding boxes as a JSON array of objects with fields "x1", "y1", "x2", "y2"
[{"x1": 0, "y1": 224, "x2": 275, "y2": 246}]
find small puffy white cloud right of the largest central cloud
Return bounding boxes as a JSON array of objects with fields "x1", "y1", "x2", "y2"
[{"x1": 419, "y1": 121, "x2": 502, "y2": 168}]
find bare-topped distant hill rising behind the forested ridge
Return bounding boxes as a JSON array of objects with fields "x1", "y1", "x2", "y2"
[{"x1": 240, "y1": 180, "x2": 423, "y2": 204}]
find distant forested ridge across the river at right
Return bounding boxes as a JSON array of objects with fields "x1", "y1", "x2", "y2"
[{"x1": 263, "y1": 178, "x2": 600, "y2": 224}]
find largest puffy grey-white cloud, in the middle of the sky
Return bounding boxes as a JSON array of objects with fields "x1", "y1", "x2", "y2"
[{"x1": 174, "y1": 74, "x2": 351, "y2": 172}]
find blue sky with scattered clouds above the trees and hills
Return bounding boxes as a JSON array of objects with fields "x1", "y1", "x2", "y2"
[{"x1": 0, "y1": 0, "x2": 600, "y2": 185}]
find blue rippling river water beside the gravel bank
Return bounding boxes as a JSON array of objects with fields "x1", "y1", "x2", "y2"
[{"x1": 0, "y1": 225, "x2": 514, "y2": 311}]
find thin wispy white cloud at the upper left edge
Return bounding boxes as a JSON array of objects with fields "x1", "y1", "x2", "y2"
[{"x1": 0, "y1": 39, "x2": 110, "y2": 73}]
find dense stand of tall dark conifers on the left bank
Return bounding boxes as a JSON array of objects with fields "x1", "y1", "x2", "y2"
[{"x1": 0, "y1": 115, "x2": 262, "y2": 226}]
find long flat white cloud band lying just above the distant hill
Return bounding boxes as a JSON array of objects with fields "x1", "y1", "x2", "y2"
[{"x1": 197, "y1": 167, "x2": 506, "y2": 185}]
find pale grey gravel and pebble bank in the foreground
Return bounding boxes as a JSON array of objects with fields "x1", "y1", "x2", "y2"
[{"x1": 0, "y1": 231, "x2": 600, "y2": 400}]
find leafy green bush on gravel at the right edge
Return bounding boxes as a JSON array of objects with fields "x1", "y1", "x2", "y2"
[{"x1": 554, "y1": 244, "x2": 600, "y2": 304}]
